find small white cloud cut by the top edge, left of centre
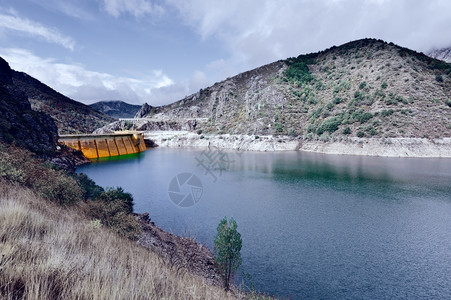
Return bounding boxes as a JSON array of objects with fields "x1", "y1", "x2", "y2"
[{"x1": 102, "y1": 0, "x2": 164, "y2": 18}]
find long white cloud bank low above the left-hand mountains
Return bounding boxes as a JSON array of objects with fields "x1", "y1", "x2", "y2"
[{"x1": 0, "y1": 48, "x2": 176, "y2": 105}]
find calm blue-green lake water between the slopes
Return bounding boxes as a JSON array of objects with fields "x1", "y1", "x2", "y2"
[{"x1": 78, "y1": 148, "x2": 451, "y2": 299}]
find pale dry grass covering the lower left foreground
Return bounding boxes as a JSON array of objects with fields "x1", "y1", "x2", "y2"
[{"x1": 0, "y1": 181, "x2": 238, "y2": 299}]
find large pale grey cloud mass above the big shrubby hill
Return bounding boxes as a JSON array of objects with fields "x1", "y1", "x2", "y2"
[{"x1": 167, "y1": 0, "x2": 451, "y2": 75}]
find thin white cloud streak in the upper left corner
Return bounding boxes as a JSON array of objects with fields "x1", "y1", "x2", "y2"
[{"x1": 0, "y1": 13, "x2": 75, "y2": 51}]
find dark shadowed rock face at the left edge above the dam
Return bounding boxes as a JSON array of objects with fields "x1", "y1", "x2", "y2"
[{"x1": 0, "y1": 58, "x2": 57, "y2": 157}]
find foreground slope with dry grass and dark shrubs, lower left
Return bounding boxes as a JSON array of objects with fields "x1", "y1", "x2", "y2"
[{"x1": 0, "y1": 144, "x2": 238, "y2": 299}]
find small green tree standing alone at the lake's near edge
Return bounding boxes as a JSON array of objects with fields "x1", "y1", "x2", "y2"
[{"x1": 214, "y1": 217, "x2": 242, "y2": 291}]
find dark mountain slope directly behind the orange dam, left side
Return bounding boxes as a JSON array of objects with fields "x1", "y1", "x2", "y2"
[{"x1": 12, "y1": 71, "x2": 114, "y2": 134}]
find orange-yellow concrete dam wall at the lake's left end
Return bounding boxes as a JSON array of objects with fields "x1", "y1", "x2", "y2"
[{"x1": 58, "y1": 131, "x2": 146, "y2": 159}]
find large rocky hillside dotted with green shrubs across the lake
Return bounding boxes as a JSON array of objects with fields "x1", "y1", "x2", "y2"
[{"x1": 103, "y1": 39, "x2": 451, "y2": 142}]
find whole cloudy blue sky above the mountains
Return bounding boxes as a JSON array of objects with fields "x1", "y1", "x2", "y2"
[{"x1": 0, "y1": 0, "x2": 451, "y2": 106}]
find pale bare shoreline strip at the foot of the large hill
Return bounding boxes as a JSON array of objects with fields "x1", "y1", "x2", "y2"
[{"x1": 145, "y1": 131, "x2": 451, "y2": 158}]
